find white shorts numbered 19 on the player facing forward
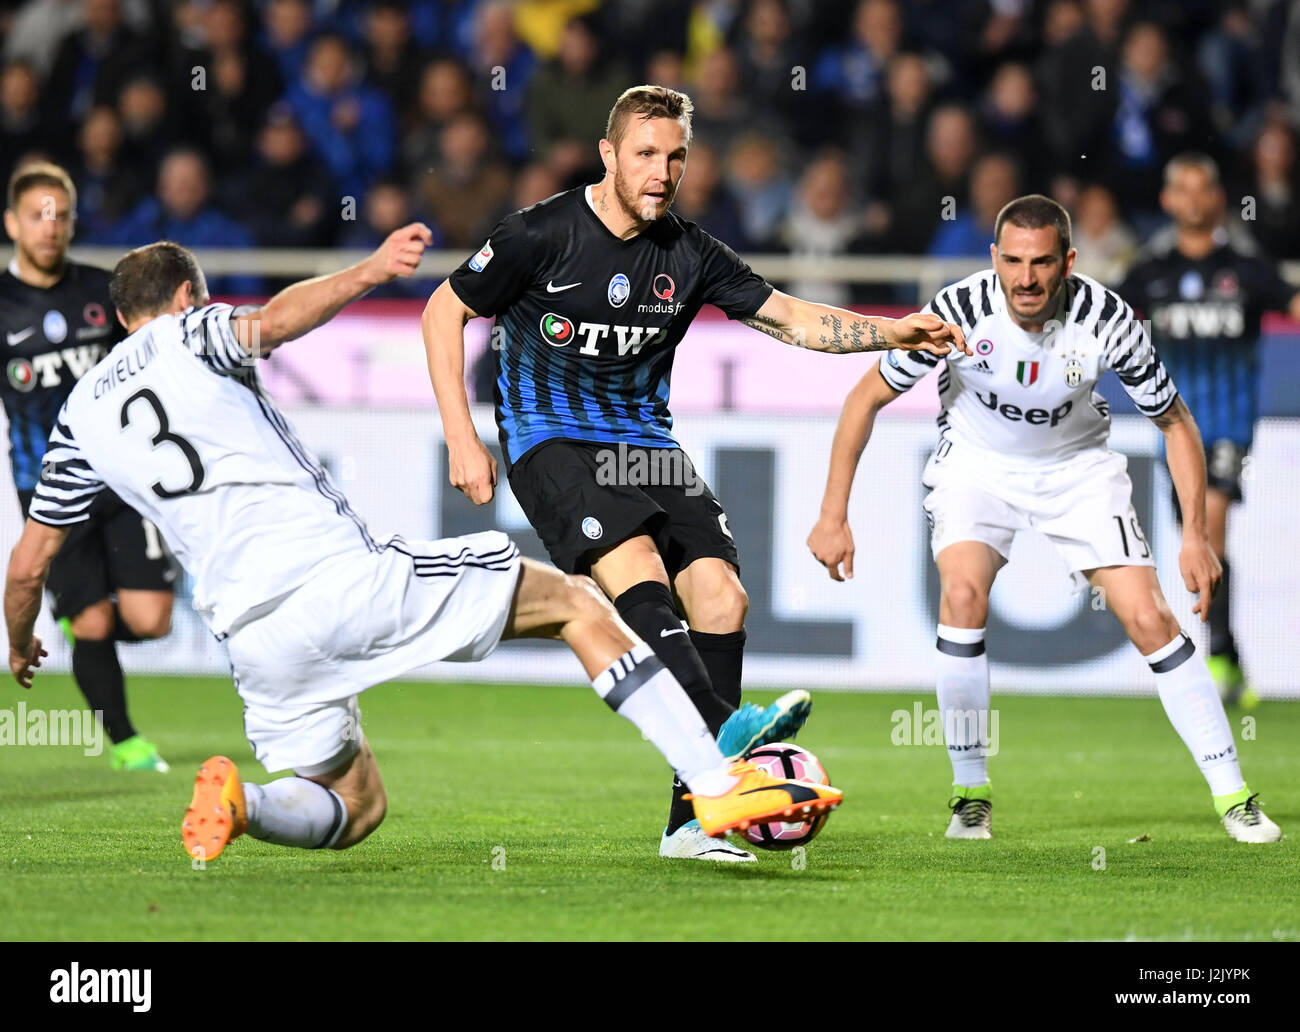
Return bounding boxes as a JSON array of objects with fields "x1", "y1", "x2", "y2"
[{"x1": 922, "y1": 448, "x2": 1156, "y2": 593}]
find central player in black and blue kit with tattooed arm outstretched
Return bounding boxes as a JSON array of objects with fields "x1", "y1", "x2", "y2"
[{"x1": 424, "y1": 86, "x2": 965, "y2": 860}]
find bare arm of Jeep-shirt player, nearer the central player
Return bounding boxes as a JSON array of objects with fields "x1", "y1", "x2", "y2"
[{"x1": 807, "y1": 365, "x2": 898, "y2": 581}]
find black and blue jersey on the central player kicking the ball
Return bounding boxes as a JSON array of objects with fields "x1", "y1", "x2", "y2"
[{"x1": 450, "y1": 187, "x2": 772, "y2": 464}]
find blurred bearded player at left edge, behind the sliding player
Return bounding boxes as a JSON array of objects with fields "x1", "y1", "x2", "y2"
[{"x1": 0, "y1": 162, "x2": 174, "y2": 771}]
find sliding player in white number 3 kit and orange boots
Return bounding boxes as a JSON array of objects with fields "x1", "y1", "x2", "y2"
[{"x1": 5, "y1": 224, "x2": 840, "y2": 859}]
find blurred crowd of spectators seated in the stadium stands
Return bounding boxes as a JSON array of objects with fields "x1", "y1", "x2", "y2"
[{"x1": 0, "y1": 0, "x2": 1300, "y2": 293}]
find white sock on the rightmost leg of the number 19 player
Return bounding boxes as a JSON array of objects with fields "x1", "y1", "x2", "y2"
[{"x1": 1143, "y1": 632, "x2": 1245, "y2": 795}]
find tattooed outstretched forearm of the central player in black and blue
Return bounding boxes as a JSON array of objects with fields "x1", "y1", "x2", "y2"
[{"x1": 741, "y1": 290, "x2": 971, "y2": 355}]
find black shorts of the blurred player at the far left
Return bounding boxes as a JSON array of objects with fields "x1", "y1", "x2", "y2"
[{"x1": 18, "y1": 490, "x2": 176, "y2": 620}]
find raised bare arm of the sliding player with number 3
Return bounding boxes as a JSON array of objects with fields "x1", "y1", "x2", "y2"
[{"x1": 231, "y1": 222, "x2": 433, "y2": 356}]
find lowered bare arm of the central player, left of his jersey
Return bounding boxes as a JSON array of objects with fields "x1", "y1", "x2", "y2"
[{"x1": 420, "y1": 279, "x2": 497, "y2": 506}]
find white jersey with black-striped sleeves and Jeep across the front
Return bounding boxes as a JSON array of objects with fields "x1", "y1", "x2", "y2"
[{"x1": 880, "y1": 269, "x2": 1178, "y2": 468}]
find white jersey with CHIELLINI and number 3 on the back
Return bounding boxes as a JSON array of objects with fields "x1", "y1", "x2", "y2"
[{"x1": 30, "y1": 304, "x2": 377, "y2": 634}]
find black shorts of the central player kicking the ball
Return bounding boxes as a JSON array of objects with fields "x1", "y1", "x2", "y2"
[{"x1": 510, "y1": 441, "x2": 740, "y2": 576}]
